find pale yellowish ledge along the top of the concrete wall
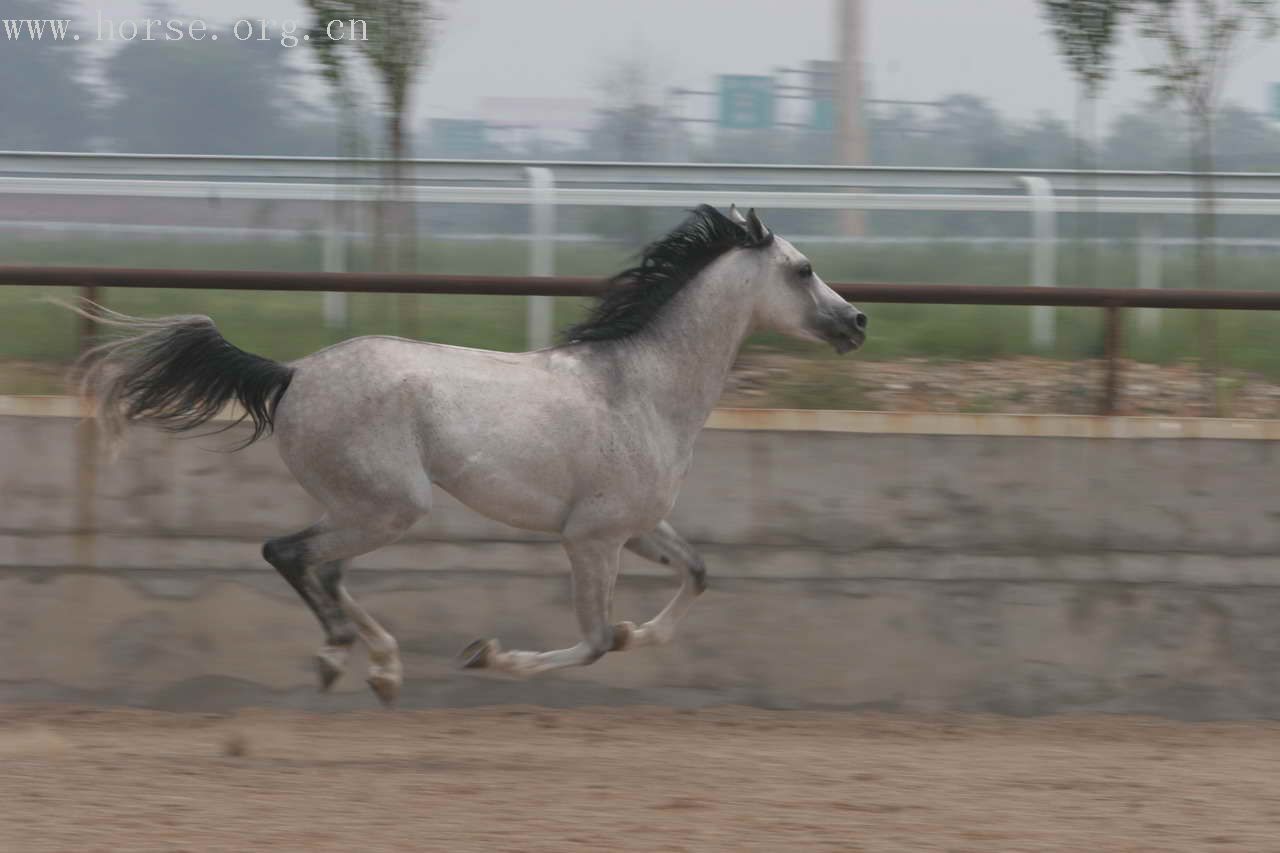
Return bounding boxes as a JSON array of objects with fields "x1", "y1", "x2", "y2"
[{"x1": 0, "y1": 396, "x2": 1280, "y2": 441}]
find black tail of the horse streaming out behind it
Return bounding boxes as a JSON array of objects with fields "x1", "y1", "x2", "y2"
[{"x1": 73, "y1": 304, "x2": 293, "y2": 447}]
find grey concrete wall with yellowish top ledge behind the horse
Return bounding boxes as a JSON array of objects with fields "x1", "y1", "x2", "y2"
[{"x1": 0, "y1": 398, "x2": 1280, "y2": 717}]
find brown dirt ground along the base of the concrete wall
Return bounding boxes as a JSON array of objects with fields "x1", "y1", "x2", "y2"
[{"x1": 0, "y1": 707, "x2": 1280, "y2": 853}]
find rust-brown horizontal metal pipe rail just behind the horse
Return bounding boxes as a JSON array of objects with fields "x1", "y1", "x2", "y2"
[{"x1": 0, "y1": 265, "x2": 1280, "y2": 414}]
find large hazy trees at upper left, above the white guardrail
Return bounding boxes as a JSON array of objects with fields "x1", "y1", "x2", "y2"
[{"x1": 0, "y1": 0, "x2": 337, "y2": 155}]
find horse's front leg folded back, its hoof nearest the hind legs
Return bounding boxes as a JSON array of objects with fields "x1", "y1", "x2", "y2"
[{"x1": 458, "y1": 538, "x2": 625, "y2": 675}]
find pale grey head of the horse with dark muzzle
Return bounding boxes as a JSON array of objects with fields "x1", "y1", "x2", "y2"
[{"x1": 730, "y1": 207, "x2": 867, "y2": 353}]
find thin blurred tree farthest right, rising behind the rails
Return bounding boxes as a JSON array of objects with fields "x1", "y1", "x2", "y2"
[{"x1": 1139, "y1": 0, "x2": 1277, "y2": 411}]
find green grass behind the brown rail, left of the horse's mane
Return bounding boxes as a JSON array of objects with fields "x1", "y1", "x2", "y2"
[{"x1": 0, "y1": 234, "x2": 626, "y2": 361}]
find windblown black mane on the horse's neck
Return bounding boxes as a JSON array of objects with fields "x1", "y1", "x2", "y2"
[{"x1": 564, "y1": 205, "x2": 773, "y2": 343}]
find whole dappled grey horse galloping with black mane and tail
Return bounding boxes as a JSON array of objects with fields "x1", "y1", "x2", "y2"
[{"x1": 74, "y1": 205, "x2": 867, "y2": 703}]
